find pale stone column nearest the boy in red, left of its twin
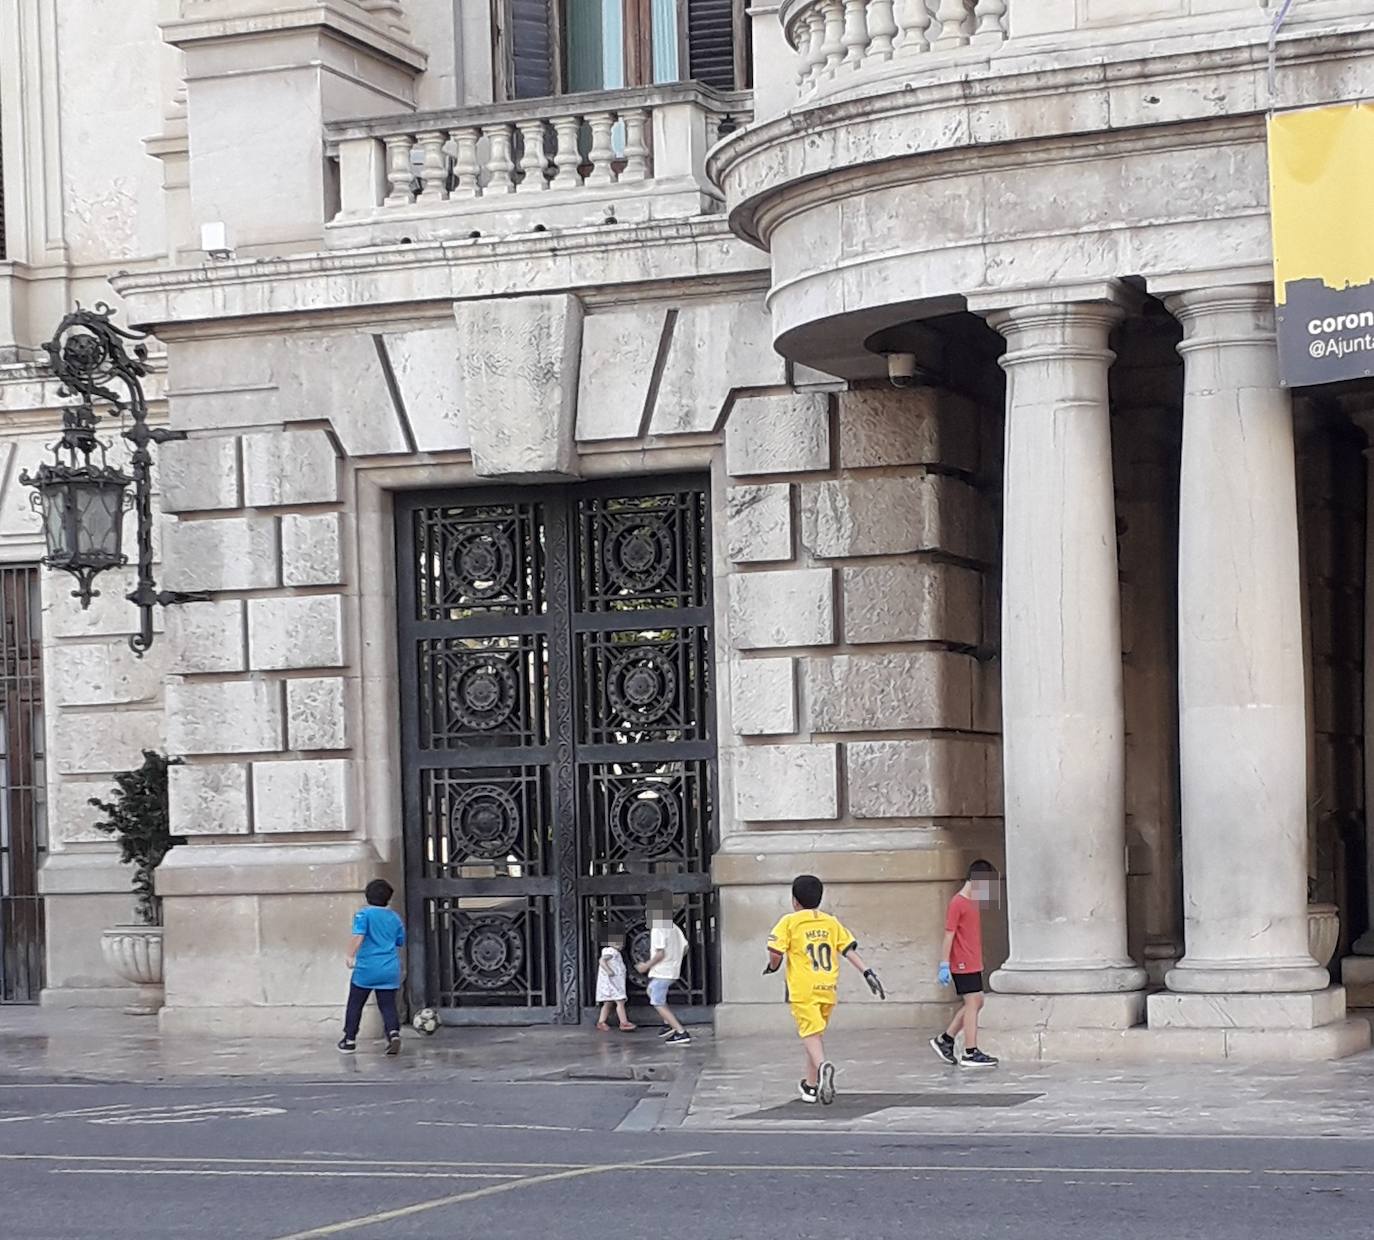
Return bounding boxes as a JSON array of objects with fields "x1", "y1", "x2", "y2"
[{"x1": 988, "y1": 286, "x2": 1145, "y2": 1006}]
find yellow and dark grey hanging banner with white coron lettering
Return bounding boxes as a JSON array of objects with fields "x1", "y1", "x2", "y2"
[{"x1": 1268, "y1": 103, "x2": 1374, "y2": 386}]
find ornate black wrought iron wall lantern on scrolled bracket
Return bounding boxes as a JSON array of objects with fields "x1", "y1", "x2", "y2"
[{"x1": 19, "y1": 304, "x2": 206, "y2": 656}]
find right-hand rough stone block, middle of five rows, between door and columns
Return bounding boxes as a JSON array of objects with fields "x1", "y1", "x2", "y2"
[{"x1": 841, "y1": 564, "x2": 982, "y2": 646}]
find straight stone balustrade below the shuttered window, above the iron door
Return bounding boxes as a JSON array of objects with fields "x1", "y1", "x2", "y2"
[{"x1": 326, "y1": 82, "x2": 752, "y2": 246}]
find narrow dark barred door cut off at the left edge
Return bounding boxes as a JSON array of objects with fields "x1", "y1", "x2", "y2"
[{"x1": 0, "y1": 566, "x2": 44, "y2": 1004}]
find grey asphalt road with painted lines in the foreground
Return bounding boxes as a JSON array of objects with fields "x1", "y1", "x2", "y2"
[{"x1": 0, "y1": 1078, "x2": 1374, "y2": 1240}]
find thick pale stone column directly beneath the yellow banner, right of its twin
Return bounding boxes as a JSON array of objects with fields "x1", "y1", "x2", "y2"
[{"x1": 1151, "y1": 285, "x2": 1327, "y2": 1000}]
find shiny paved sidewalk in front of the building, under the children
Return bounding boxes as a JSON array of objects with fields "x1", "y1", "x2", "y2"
[{"x1": 0, "y1": 1008, "x2": 1374, "y2": 1138}]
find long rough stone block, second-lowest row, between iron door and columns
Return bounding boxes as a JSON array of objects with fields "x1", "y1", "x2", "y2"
[{"x1": 807, "y1": 650, "x2": 973, "y2": 733}]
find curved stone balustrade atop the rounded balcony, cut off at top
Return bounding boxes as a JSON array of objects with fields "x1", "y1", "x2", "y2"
[{"x1": 779, "y1": 0, "x2": 1025, "y2": 98}]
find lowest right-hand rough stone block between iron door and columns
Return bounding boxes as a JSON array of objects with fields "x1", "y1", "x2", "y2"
[{"x1": 845, "y1": 737, "x2": 998, "y2": 818}]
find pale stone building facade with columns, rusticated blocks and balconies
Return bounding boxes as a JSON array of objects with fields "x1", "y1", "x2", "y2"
[{"x1": 0, "y1": 0, "x2": 1374, "y2": 1059}]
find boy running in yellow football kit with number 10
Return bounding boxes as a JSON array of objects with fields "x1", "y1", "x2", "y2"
[{"x1": 764, "y1": 874, "x2": 888, "y2": 1107}]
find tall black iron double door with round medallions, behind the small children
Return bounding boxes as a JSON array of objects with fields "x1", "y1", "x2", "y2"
[{"x1": 397, "y1": 477, "x2": 717, "y2": 1023}]
